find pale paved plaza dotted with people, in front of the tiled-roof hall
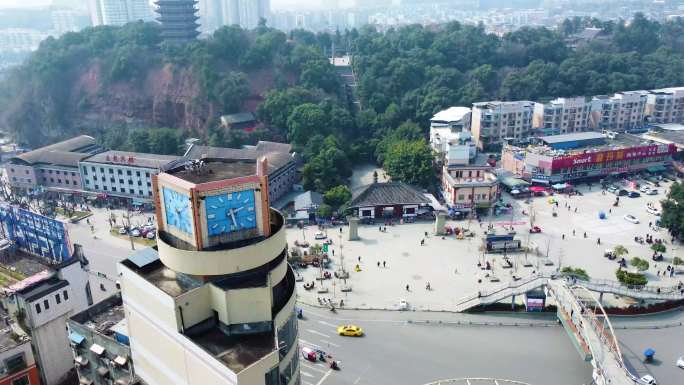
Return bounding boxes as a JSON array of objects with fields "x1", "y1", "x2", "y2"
[{"x1": 288, "y1": 178, "x2": 684, "y2": 310}]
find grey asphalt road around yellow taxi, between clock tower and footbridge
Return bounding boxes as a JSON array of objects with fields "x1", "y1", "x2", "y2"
[{"x1": 299, "y1": 307, "x2": 591, "y2": 385}]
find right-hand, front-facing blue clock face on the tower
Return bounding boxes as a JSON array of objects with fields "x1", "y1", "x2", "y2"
[{"x1": 204, "y1": 190, "x2": 257, "y2": 236}]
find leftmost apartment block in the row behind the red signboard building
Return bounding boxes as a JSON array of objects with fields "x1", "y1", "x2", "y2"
[{"x1": 471, "y1": 101, "x2": 534, "y2": 149}]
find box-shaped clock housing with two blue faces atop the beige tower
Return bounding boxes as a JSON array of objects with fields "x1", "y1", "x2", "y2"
[{"x1": 153, "y1": 158, "x2": 270, "y2": 250}]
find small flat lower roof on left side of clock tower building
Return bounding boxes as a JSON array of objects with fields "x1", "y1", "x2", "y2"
[{"x1": 121, "y1": 247, "x2": 203, "y2": 297}]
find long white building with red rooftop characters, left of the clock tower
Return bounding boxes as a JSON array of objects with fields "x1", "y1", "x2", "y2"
[{"x1": 79, "y1": 151, "x2": 180, "y2": 202}]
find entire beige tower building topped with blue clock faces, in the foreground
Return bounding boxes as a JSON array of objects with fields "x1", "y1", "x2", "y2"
[{"x1": 120, "y1": 159, "x2": 300, "y2": 385}]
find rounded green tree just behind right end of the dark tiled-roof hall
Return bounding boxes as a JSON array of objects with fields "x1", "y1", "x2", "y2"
[{"x1": 384, "y1": 139, "x2": 435, "y2": 187}]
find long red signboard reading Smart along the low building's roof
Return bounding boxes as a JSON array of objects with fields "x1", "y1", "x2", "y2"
[{"x1": 551, "y1": 144, "x2": 677, "y2": 169}]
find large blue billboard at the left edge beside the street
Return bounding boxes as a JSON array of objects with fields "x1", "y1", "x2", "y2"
[{"x1": 0, "y1": 205, "x2": 73, "y2": 263}]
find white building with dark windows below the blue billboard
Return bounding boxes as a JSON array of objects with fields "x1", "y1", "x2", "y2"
[{"x1": 2, "y1": 245, "x2": 93, "y2": 385}]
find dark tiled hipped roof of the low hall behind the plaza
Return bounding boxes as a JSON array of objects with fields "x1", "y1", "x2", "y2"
[{"x1": 349, "y1": 182, "x2": 430, "y2": 208}]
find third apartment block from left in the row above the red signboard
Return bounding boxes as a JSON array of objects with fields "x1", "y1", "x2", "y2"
[{"x1": 590, "y1": 91, "x2": 648, "y2": 132}]
